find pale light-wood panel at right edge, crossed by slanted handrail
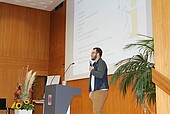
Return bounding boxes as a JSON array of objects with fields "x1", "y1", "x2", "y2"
[{"x1": 153, "y1": 0, "x2": 170, "y2": 114}]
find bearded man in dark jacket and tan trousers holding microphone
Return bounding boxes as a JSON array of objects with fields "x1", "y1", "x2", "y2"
[{"x1": 89, "y1": 47, "x2": 109, "y2": 114}]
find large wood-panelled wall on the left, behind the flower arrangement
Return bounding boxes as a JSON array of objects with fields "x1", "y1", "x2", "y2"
[{"x1": 0, "y1": 3, "x2": 50, "y2": 114}]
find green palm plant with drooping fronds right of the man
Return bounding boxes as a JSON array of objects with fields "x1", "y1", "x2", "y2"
[{"x1": 110, "y1": 34, "x2": 156, "y2": 114}]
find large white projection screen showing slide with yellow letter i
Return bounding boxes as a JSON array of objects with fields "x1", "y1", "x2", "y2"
[{"x1": 66, "y1": 0, "x2": 152, "y2": 80}]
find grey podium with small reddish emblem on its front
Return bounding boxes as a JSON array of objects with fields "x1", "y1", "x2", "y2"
[{"x1": 44, "y1": 84, "x2": 81, "y2": 114}]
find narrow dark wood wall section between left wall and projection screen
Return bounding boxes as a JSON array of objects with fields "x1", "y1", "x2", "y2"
[{"x1": 49, "y1": 2, "x2": 66, "y2": 80}]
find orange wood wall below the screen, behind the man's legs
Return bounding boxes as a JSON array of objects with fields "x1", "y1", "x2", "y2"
[{"x1": 68, "y1": 76, "x2": 155, "y2": 114}]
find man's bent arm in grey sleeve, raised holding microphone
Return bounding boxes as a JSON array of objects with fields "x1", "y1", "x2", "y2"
[{"x1": 91, "y1": 61, "x2": 107, "y2": 79}]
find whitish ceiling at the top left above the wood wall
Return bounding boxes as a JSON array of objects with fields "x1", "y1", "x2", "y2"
[{"x1": 0, "y1": 0, "x2": 64, "y2": 11}]
